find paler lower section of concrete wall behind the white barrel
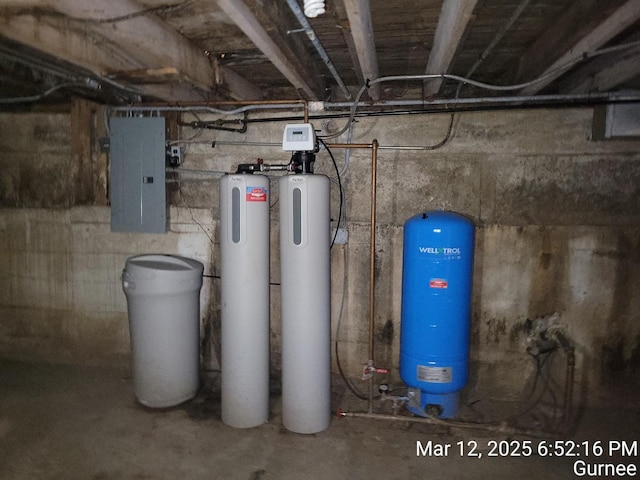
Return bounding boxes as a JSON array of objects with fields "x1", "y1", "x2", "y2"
[{"x1": 0, "y1": 207, "x2": 217, "y2": 367}]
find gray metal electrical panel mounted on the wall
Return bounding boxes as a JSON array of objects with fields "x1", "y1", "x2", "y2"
[{"x1": 109, "y1": 117, "x2": 169, "y2": 233}]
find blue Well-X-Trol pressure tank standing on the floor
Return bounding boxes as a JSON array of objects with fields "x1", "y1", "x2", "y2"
[{"x1": 400, "y1": 211, "x2": 474, "y2": 418}]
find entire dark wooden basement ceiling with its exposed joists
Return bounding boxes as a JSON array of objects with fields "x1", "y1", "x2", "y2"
[{"x1": 0, "y1": 0, "x2": 640, "y2": 103}]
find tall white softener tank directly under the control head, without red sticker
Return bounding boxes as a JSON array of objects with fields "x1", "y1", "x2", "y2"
[{"x1": 279, "y1": 173, "x2": 331, "y2": 434}]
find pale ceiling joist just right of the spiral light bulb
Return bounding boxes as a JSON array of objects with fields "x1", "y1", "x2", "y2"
[{"x1": 344, "y1": 0, "x2": 380, "y2": 100}]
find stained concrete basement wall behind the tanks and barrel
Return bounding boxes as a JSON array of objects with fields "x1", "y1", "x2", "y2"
[{"x1": 0, "y1": 108, "x2": 640, "y2": 405}]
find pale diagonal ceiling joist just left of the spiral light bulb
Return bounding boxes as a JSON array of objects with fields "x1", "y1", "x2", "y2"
[{"x1": 218, "y1": 0, "x2": 318, "y2": 100}]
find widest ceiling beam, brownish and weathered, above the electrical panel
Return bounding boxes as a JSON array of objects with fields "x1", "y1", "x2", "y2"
[{"x1": 0, "y1": 0, "x2": 261, "y2": 101}]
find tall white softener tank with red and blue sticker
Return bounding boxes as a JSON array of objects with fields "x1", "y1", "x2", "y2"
[{"x1": 220, "y1": 173, "x2": 270, "y2": 428}]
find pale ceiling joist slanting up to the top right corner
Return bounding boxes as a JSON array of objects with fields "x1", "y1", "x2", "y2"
[{"x1": 520, "y1": 0, "x2": 640, "y2": 95}]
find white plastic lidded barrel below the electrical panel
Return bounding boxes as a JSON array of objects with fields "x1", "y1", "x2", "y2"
[{"x1": 122, "y1": 255, "x2": 204, "y2": 408}]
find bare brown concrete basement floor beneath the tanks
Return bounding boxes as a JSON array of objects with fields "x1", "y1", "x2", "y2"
[{"x1": 0, "y1": 360, "x2": 640, "y2": 480}]
